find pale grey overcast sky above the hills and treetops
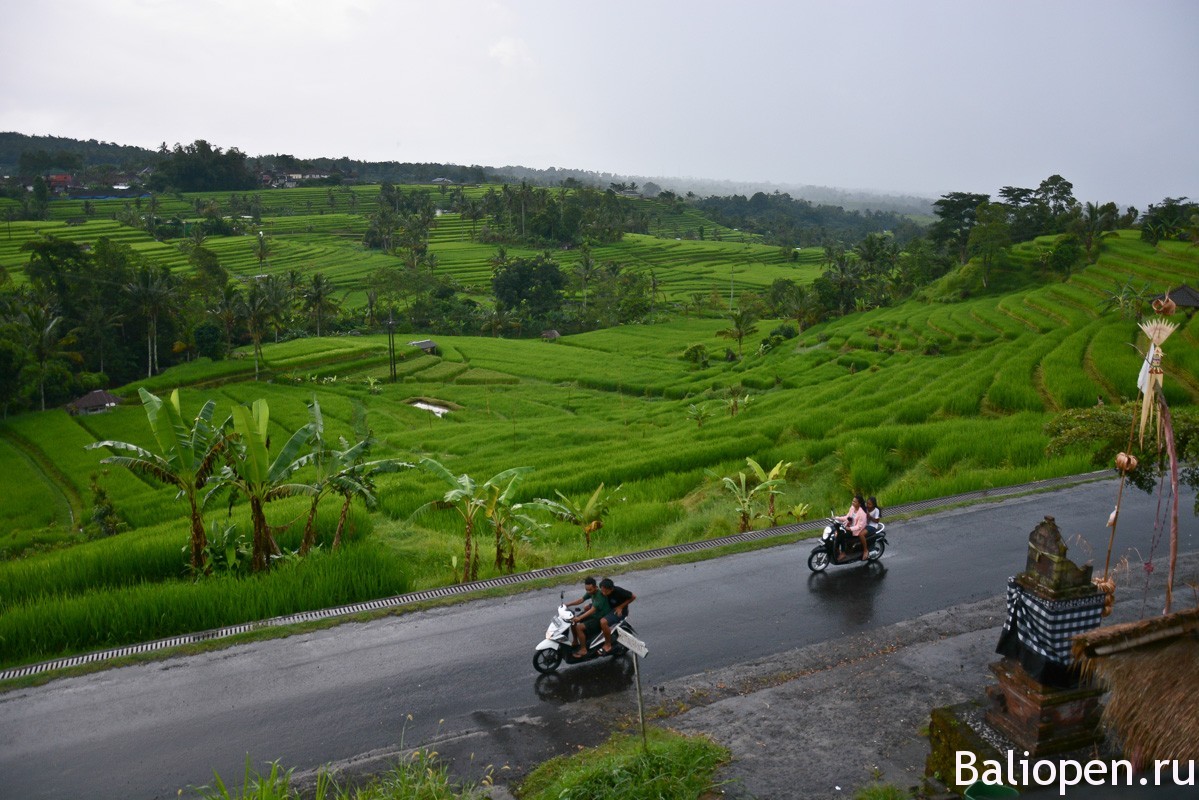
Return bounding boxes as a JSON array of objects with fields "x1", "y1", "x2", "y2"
[{"x1": 0, "y1": 0, "x2": 1199, "y2": 210}]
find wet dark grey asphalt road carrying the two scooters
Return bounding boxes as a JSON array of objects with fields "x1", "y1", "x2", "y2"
[{"x1": 0, "y1": 481, "x2": 1199, "y2": 800}]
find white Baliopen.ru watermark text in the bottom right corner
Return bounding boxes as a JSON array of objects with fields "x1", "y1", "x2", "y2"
[{"x1": 954, "y1": 750, "x2": 1197, "y2": 795}]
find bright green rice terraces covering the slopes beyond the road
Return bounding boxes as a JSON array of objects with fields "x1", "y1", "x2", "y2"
[{"x1": 0, "y1": 187, "x2": 1199, "y2": 667}]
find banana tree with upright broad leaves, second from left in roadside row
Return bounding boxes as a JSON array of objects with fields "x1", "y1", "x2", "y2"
[{"x1": 205, "y1": 398, "x2": 317, "y2": 572}]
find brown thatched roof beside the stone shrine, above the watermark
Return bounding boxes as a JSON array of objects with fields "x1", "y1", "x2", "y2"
[{"x1": 1073, "y1": 608, "x2": 1199, "y2": 764}]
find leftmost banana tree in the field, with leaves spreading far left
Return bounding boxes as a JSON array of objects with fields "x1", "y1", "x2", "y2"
[{"x1": 88, "y1": 389, "x2": 229, "y2": 573}]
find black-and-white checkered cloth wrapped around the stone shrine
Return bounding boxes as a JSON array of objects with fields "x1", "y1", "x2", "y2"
[{"x1": 1004, "y1": 578, "x2": 1103, "y2": 666}]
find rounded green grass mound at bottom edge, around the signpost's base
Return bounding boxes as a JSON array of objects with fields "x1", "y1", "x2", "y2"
[{"x1": 517, "y1": 728, "x2": 729, "y2": 800}]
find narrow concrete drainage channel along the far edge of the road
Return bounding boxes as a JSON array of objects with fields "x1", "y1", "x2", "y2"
[{"x1": 0, "y1": 470, "x2": 1111, "y2": 680}]
